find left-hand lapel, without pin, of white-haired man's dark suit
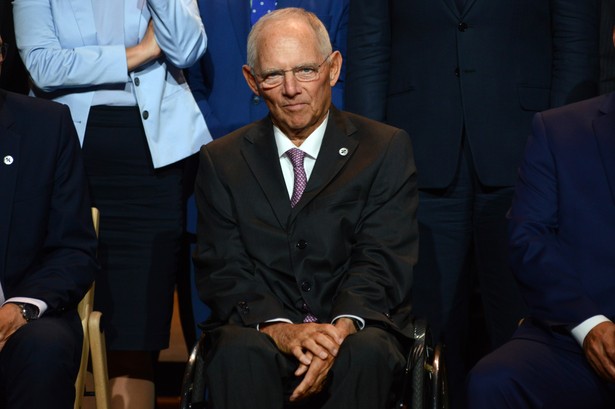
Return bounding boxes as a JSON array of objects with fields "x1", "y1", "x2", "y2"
[{"x1": 241, "y1": 117, "x2": 291, "y2": 228}]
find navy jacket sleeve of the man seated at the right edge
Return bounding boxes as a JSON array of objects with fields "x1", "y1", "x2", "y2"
[{"x1": 509, "y1": 114, "x2": 602, "y2": 325}]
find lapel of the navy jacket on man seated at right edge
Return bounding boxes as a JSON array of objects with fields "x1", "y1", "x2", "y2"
[{"x1": 593, "y1": 93, "x2": 615, "y2": 206}]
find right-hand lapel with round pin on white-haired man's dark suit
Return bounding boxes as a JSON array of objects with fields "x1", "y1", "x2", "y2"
[{"x1": 291, "y1": 107, "x2": 358, "y2": 220}]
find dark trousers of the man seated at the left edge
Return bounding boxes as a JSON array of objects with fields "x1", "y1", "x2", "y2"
[{"x1": 0, "y1": 312, "x2": 83, "y2": 409}]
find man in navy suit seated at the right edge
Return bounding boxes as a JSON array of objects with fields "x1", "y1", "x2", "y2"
[{"x1": 468, "y1": 27, "x2": 615, "y2": 409}]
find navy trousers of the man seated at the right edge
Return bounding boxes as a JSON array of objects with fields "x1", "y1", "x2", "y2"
[{"x1": 468, "y1": 321, "x2": 615, "y2": 409}]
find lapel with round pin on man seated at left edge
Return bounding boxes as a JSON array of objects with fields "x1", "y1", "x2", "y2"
[{"x1": 0, "y1": 92, "x2": 20, "y2": 280}]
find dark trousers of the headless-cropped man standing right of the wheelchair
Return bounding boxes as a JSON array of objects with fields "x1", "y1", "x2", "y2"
[{"x1": 413, "y1": 143, "x2": 526, "y2": 409}]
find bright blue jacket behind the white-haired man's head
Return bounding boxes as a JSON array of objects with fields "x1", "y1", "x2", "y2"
[{"x1": 187, "y1": 0, "x2": 348, "y2": 138}]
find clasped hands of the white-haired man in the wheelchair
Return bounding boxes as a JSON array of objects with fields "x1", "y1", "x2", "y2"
[{"x1": 260, "y1": 318, "x2": 356, "y2": 402}]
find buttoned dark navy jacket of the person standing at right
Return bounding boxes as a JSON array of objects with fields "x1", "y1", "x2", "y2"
[{"x1": 346, "y1": 0, "x2": 599, "y2": 188}]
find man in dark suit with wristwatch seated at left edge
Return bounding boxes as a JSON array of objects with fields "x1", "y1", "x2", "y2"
[{"x1": 0, "y1": 32, "x2": 98, "y2": 409}]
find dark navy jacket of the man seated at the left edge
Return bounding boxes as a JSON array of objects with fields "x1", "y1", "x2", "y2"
[{"x1": 0, "y1": 91, "x2": 97, "y2": 314}]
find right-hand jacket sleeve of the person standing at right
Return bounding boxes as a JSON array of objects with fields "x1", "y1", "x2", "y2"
[{"x1": 551, "y1": 0, "x2": 600, "y2": 107}]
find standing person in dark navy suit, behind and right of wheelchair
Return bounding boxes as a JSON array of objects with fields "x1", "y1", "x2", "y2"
[{"x1": 345, "y1": 0, "x2": 599, "y2": 408}]
